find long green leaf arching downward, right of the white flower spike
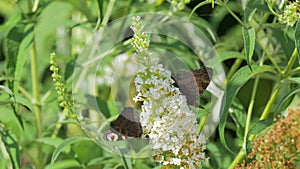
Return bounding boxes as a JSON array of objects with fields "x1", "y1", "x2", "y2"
[{"x1": 219, "y1": 65, "x2": 275, "y2": 150}]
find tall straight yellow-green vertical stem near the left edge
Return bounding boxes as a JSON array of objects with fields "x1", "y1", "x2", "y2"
[{"x1": 31, "y1": 37, "x2": 44, "y2": 169}]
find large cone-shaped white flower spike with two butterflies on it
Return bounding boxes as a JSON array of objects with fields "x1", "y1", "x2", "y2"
[{"x1": 131, "y1": 17, "x2": 207, "y2": 169}]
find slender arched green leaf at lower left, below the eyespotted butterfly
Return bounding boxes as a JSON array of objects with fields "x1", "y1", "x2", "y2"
[{"x1": 51, "y1": 137, "x2": 92, "y2": 164}]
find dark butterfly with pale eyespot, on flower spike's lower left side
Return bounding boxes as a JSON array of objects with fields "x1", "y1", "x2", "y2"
[{"x1": 104, "y1": 107, "x2": 143, "y2": 141}]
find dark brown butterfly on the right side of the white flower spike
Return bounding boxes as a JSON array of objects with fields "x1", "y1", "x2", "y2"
[{"x1": 172, "y1": 67, "x2": 213, "y2": 107}]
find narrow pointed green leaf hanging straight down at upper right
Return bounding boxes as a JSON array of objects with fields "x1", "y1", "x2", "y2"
[{"x1": 242, "y1": 27, "x2": 255, "y2": 69}]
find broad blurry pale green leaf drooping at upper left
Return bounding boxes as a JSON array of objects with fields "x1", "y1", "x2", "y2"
[{"x1": 34, "y1": 1, "x2": 75, "y2": 77}]
